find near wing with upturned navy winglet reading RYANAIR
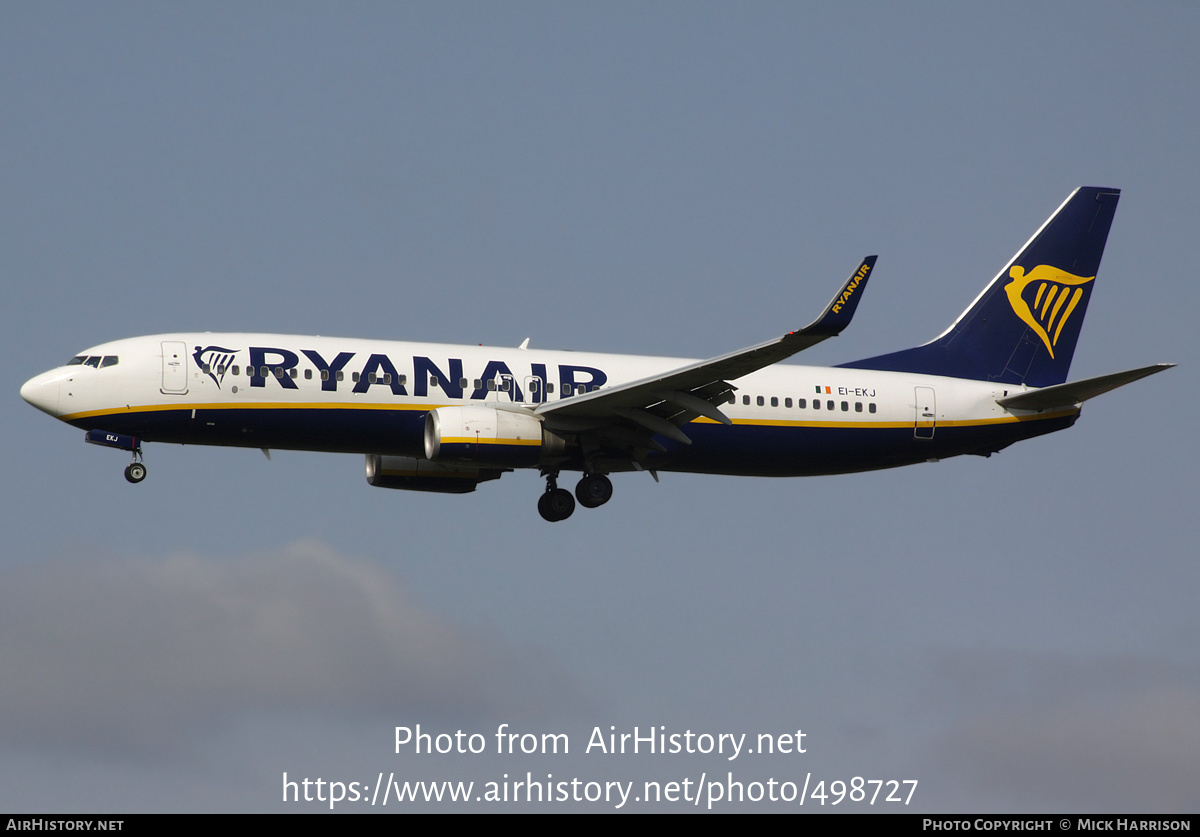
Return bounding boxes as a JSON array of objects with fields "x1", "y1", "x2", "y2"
[{"x1": 535, "y1": 255, "x2": 877, "y2": 459}]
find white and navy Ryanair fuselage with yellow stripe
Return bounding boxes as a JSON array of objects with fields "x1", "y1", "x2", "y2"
[{"x1": 22, "y1": 333, "x2": 1079, "y2": 476}]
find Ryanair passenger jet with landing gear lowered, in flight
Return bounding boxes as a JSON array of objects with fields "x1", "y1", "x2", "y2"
[{"x1": 20, "y1": 187, "x2": 1174, "y2": 522}]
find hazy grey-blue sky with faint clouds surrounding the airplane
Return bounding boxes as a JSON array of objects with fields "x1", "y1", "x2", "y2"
[{"x1": 0, "y1": 2, "x2": 1200, "y2": 813}]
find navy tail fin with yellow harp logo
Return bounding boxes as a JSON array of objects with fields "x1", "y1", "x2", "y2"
[{"x1": 842, "y1": 186, "x2": 1121, "y2": 387}]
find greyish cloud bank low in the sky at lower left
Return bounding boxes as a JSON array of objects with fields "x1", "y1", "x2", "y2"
[{"x1": 0, "y1": 542, "x2": 576, "y2": 749}]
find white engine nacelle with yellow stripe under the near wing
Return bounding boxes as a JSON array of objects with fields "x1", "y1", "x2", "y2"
[{"x1": 425, "y1": 404, "x2": 566, "y2": 468}]
